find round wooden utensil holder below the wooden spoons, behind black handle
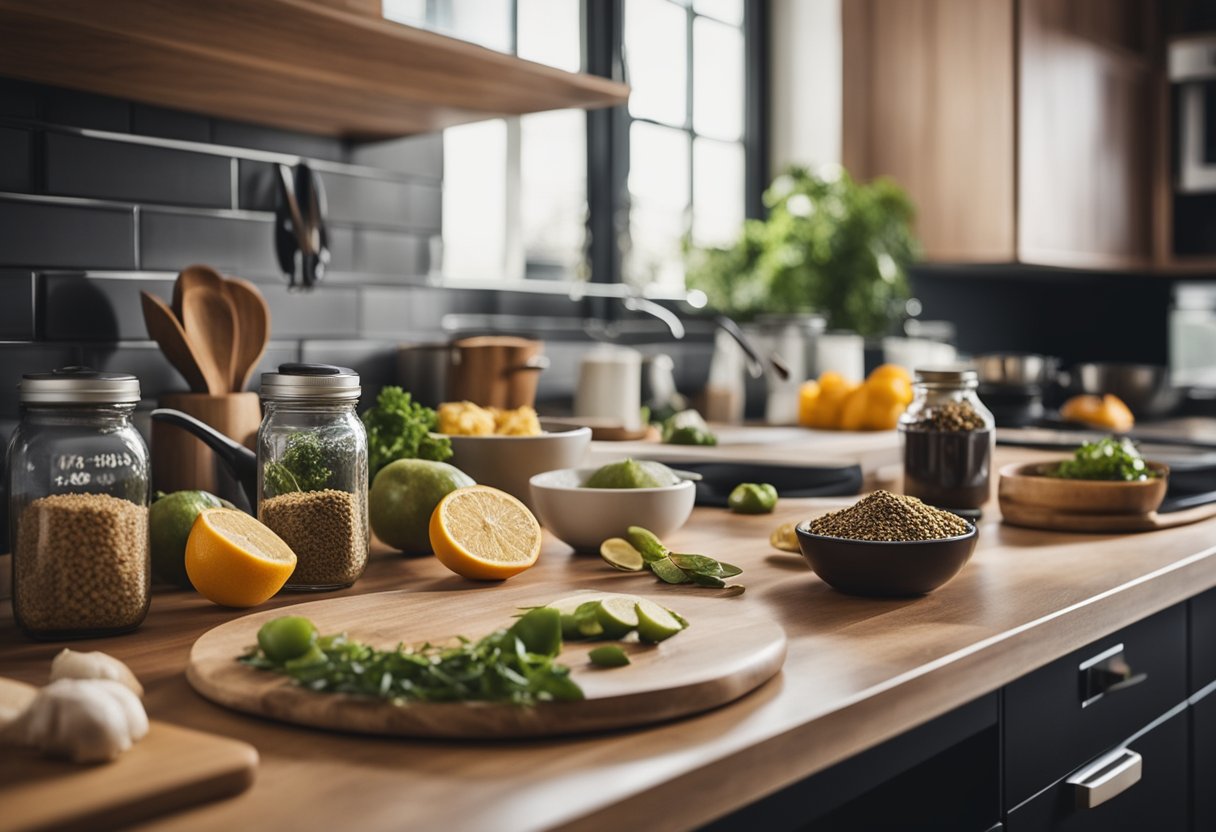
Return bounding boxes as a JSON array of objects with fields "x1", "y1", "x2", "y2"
[{"x1": 152, "y1": 393, "x2": 261, "y2": 510}]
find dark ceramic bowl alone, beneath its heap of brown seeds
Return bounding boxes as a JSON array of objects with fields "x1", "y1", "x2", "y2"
[{"x1": 796, "y1": 521, "x2": 975, "y2": 597}]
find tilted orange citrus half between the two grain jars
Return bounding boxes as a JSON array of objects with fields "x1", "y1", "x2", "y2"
[{"x1": 186, "y1": 508, "x2": 295, "y2": 607}]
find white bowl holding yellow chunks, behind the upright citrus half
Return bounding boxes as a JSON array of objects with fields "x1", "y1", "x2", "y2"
[{"x1": 447, "y1": 427, "x2": 591, "y2": 511}]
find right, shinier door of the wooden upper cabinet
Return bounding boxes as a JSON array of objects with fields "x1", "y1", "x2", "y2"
[{"x1": 1018, "y1": 0, "x2": 1156, "y2": 268}]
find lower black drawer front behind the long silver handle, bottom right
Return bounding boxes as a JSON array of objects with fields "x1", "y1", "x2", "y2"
[{"x1": 1006, "y1": 710, "x2": 1186, "y2": 832}]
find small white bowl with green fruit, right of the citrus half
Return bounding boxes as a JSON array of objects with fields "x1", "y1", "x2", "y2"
[{"x1": 531, "y1": 468, "x2": 697, "y2": 552}]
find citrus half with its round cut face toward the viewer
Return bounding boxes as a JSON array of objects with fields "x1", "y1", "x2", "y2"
[{"x1": 430, "y1": 485, "x2": 541, "y2": 580}]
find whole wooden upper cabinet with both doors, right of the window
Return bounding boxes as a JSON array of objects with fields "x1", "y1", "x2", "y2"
[{"x1": 843, "y1": 0, "x2": 1155, "y2": 268}]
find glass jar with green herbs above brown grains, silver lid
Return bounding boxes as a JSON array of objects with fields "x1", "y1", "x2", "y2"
[{"x1": 258, "y1": 364, "x2": 368, "y2": 591}]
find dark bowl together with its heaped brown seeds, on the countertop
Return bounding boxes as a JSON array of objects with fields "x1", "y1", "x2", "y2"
[{"x1": 795, "y1": 490, "x2": 976, "y2": 597}]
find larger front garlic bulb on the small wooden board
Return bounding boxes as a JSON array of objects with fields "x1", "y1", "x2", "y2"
[{"x1": 0, "y1": 679, "x2": 148, "y2": 763}]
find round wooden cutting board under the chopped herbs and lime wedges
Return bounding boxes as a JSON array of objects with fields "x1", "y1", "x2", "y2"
[{"x1": 186, "y1": 588, "x2": 786, "y2": 740}]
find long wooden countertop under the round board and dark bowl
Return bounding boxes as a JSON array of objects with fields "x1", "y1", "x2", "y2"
[{"x1": 0, "y1": 449, "x2": 1216, "y2": 832}]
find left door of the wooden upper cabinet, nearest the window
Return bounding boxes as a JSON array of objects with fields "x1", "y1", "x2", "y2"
[{"x1": 840, "y1": 0, "x2": 1015, "y2": 263}]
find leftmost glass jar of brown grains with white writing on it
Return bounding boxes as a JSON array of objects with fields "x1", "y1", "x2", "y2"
[{"x1": 7, "y1": 367, "x2": 151, "y2": 639}]
